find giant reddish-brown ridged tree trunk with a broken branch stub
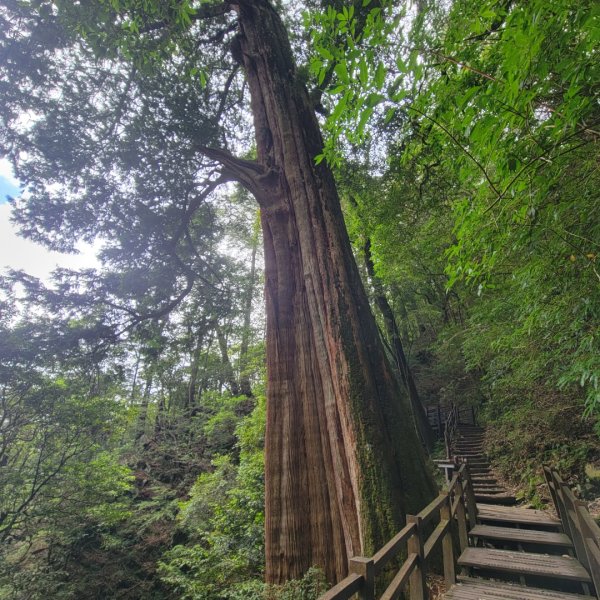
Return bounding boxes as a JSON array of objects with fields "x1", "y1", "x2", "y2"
[{"x1": 213, "y1": 0, "x2": 435, "y2": 582}]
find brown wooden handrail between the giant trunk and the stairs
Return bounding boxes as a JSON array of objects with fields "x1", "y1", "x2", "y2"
[{"x1": 319, "y1": 463, "x2": 475, "y2": 600}]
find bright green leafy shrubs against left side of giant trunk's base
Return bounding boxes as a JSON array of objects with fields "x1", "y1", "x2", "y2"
[{"x1": 160, "y1": 399, "x2": 265, "y2": 600}]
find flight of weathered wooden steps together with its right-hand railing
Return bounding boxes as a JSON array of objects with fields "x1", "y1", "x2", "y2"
[{"x1": 445, "y1": 426, "x2": 600, "y2": 600}]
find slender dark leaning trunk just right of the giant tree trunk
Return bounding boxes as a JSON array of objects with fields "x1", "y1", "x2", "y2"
[{"x1": 363, "y1": 237, "x2": 435, "y2": 450}]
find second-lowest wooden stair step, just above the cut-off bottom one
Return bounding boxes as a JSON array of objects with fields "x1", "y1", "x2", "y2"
[{"x1": 458, "y1": 548, "x2": 592, "y2": 583}]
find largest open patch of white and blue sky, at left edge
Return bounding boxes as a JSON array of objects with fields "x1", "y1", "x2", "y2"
[{"x1": 0, "y1": 158, "x2": 98, "y2": 281}]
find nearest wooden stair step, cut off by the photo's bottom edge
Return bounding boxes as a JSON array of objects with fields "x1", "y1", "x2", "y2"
[{"x1": 444, "y1": 577, "x2": 593, "y2": 600}]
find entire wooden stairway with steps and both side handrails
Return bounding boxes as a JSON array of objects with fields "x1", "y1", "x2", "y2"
[{"x1": 320, "y1": 414, "x2": 600, "y2": 600}]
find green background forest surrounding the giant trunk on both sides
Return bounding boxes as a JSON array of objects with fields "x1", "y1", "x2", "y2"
[{"x1": 0, "y1": 0, "x2": 600, "y2": 600}]
